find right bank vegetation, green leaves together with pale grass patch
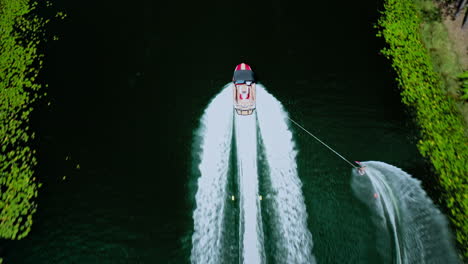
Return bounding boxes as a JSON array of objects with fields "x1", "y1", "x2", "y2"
[{"x1": 377, "y1": 0, "x2": 468, "y2": 259}]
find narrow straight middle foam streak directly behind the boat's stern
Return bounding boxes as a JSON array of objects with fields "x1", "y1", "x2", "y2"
[{"x1": 235, "y1": 114, "x2": 265, "y2": 264}]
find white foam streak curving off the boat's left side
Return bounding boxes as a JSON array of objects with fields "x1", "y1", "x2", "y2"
[{"x1": 191, "y1": 86, "x2": 233, "y2": 264}]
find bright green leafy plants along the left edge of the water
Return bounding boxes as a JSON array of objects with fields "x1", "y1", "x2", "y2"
[{"x1": 0, "y1": 0, "x2": 46, "y2": 239}]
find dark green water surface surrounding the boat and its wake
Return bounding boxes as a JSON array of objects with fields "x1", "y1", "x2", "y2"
[{"x1": 3, "y1": 0, "x2": 442, "y2": 264}]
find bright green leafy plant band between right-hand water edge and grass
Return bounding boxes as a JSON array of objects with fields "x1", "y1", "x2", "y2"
[{"x1": 378, "y1": 0, "x2": 468, "y2": 257}]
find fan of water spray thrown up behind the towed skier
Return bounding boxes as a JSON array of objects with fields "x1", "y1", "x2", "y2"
[{"x1": 351, "y1": 161, "x2": 458, "y2": 264}]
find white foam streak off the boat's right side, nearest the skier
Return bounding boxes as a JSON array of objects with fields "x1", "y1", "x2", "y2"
[{"x1": 257, "y1": 85, "x2": 315, "y2": 263}]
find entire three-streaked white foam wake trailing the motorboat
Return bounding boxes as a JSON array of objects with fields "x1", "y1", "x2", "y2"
[{"x1": 191, "y1": 84, "x2": 315, "y2": 264}]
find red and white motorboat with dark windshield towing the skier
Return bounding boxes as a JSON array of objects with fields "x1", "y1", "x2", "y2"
[{"x1": 232, "y1": 63, "x2": 256, "y2": 115}]
